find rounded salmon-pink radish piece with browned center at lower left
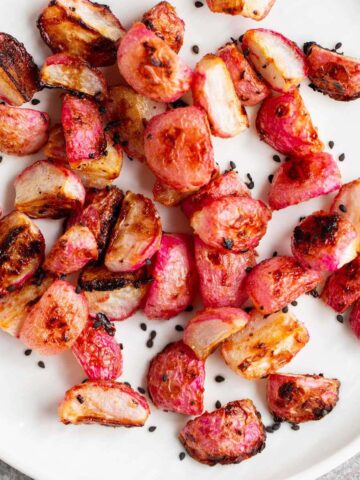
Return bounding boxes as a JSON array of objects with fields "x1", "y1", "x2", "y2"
[{"x1": 20, "y1": 280, "x2": 88, "y2": 355}]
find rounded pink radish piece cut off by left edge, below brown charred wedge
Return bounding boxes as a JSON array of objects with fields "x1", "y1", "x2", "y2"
[{"x1": 0, "y1": 104, "x2": 50, "y2": 157}]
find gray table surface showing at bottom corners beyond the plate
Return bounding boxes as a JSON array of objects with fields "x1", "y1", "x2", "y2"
[{"x1": 0, "y1": 453, "x2": 360, "y2": 480}]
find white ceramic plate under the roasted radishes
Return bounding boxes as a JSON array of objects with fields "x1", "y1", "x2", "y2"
[{"x1": 0, "y1": 0, "x2": 360, "y2": 480}]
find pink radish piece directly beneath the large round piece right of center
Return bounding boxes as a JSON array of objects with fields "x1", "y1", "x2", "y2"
[{"x1": 195, "y1": 236, "x2": 256, "y2": 307}]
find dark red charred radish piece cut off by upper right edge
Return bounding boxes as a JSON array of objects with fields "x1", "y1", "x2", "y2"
[{"x1": 304, "y1": 42, "x2": 360, "y2": 101}]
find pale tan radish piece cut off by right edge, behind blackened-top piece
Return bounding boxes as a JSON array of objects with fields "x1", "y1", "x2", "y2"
[{"x1": 331, "y1": 178, "x2": 360, "y2": 251}]
